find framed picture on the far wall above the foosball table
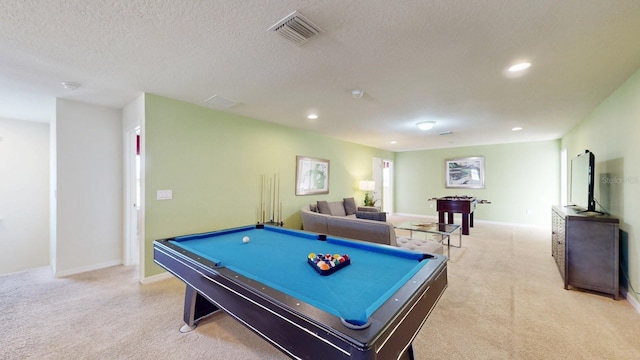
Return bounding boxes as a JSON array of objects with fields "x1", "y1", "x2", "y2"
[{"x1": 444, "y1": 156, "x2": 484, "y2": 189}]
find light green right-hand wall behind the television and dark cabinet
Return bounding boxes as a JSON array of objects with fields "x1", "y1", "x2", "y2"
[{"x1": 561, "y1": 70, "x2": 640, "y2": 300}]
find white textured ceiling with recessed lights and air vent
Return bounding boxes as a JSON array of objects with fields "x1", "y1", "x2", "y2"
[{"x1": 0, "y1": 0, "x2": 640, "y2": 151}]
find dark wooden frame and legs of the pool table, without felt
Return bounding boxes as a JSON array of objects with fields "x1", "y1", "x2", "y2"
[{"x1": 153, "y1": 225, "x2": 447, "y2": 360}]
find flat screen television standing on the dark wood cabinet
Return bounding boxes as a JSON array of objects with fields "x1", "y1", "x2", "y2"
[{"x1": 569, "y1": 150, "x2": 596, "y2": 211}]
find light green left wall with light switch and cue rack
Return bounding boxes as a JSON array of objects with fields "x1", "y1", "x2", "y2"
[{"x1": 142, "y1": 94, "x2": 394, "y2": 277}]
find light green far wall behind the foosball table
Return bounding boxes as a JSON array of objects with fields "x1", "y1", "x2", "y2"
[{"x1": 395, "y1": 140, "x2": 560, "y2": 226}]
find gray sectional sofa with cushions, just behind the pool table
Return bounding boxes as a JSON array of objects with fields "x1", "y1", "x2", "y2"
[{"x1": 301, "y1": 199, "x2": 442, "y2": 254}]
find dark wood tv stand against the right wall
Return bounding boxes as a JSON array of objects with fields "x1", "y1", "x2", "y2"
[{"x1": 551, "y1": 206, "x2": 620, "y2": 300}]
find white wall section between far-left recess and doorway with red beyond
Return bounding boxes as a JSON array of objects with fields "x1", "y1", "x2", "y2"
[{"x1": 52, "y1": 99, "x2": 123, "y2": 276}]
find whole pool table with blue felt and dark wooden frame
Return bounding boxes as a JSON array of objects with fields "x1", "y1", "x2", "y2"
[{"x1": 153, "y1": 224, "x2": 447, "y2": 360}]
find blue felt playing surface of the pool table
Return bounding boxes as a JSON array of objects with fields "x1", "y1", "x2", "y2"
[{"x1": 171, "y1": 226, "x2": 430, "y2": 325}]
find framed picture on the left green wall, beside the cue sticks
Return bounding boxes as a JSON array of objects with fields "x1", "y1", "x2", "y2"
[{"x1": 296, "y1": 156, "x2": 329, "y2": 195}]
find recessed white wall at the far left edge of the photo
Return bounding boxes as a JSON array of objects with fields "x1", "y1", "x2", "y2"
[{"x1": 0, "y1": 118, "x2": 49, "y2": 274}]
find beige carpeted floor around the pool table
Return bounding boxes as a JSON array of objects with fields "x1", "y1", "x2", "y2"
[{"x1": 0, "y1": 219, "x2": 640, "y2": 360}]
